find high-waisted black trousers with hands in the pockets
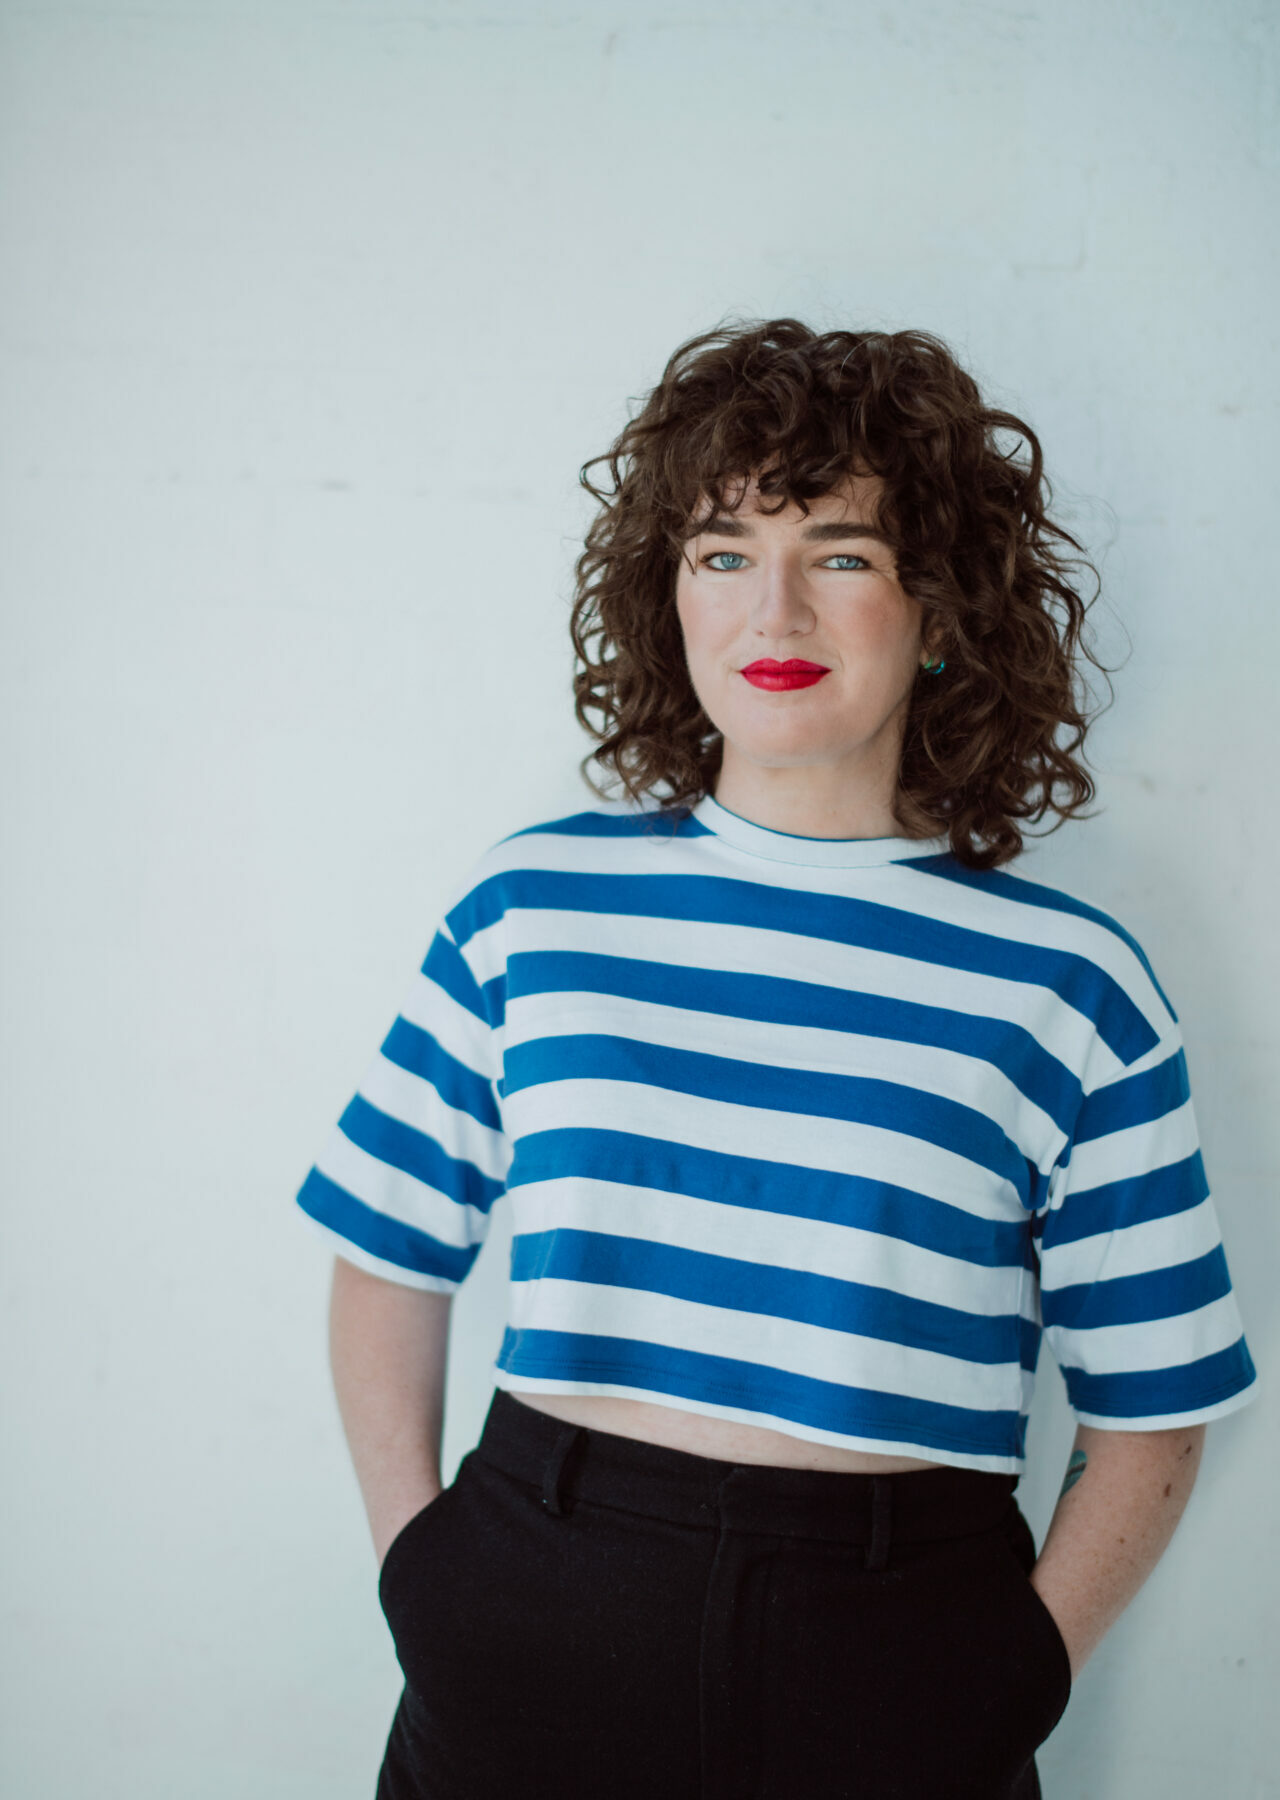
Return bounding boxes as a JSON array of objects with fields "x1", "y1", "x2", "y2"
[{"x1": 376, "y1": 1388, "x2": 1071, "y2": 1800}]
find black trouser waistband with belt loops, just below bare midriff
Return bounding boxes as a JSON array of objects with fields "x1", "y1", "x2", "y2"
[{"x1": 472, "y1": 1388, "x2": 1019, "y2": 1566}]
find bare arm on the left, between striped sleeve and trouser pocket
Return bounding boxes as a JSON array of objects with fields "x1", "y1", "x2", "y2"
[{"x1": 329, "y1": 1256, "x2": 454, "y2": 1568}]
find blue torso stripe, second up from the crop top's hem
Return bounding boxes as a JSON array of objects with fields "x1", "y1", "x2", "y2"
[{"x1": 511, "y1": 1226, "x2": 1021, "y2": 1363}]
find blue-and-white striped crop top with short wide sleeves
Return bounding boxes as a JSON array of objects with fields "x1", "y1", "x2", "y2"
[{"x1": 297, "y1": 796, "x2": 1257, "y2": 1474}]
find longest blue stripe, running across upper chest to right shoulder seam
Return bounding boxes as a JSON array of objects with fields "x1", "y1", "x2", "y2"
[{"x1": 448, "y1": 869, "x2": 1159, "y2": 1062}]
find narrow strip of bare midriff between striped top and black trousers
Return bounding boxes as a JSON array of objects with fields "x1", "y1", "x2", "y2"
[{"x1": 508, "y1": 1388, "x2": 947, "y2": 1474}]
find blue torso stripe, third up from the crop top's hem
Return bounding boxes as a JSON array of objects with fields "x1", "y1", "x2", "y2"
[{"x1": 506, "y1": 1127, "x2": 1032, "y2": 1269}]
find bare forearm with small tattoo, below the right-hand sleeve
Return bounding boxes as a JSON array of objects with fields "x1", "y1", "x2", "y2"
[{"x1": 1032, "y1": 1426, "x2": 1208, "y2": 1678}]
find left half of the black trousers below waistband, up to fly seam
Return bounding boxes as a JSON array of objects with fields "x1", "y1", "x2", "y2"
[{"x1": 383, "y1": 1458, "x2": 717, "y2": 1800}]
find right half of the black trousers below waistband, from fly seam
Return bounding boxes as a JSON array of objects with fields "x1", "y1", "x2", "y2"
[{"x1": 730, "y1": 1526, "x2": 1069, "y2": 1800}]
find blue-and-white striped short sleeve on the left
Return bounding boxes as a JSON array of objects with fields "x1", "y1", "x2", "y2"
[{"x1": 297, "y1": 916, "x2": 509, "y2": 1292}]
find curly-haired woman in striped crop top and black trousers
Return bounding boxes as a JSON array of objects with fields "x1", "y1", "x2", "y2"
[{"x1": 299, "y1": 319, "x2": 1257, "y2": 1800}]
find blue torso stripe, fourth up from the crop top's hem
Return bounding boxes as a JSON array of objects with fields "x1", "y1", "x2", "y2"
[{"x1": 502, "y1": 1033, "x2": 1039, "y2": 1208}]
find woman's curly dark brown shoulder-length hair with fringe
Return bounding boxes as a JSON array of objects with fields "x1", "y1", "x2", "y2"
[{"x1": 571, "y1": 319, "x2": 1105, "y2": 869}]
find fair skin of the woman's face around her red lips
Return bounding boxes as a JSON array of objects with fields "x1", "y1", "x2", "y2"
[{"x1": 675, "y1": 477, "x2": 924, "y2": 801}]
